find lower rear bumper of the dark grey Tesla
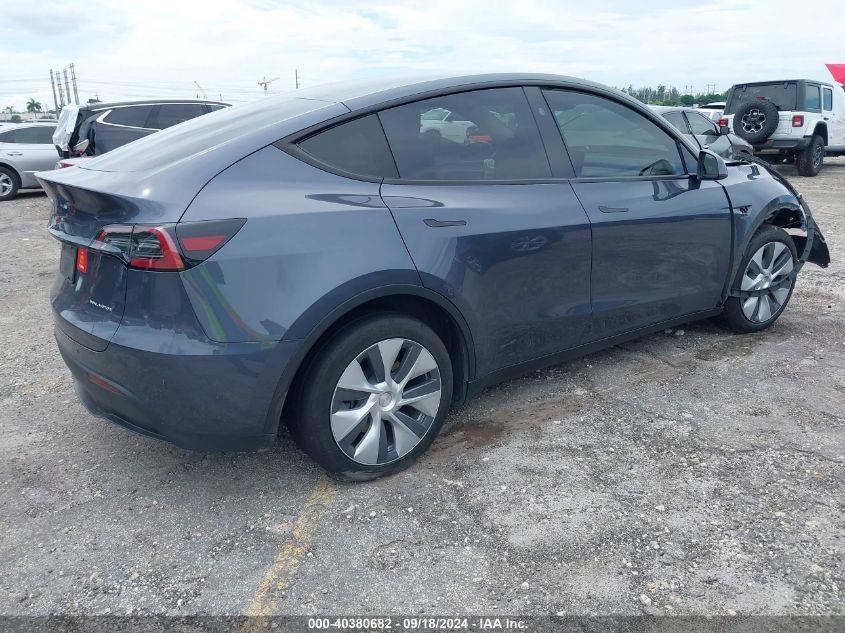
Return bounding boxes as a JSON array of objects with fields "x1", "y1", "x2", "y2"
[{"x1": 55, "y1": 324, "x2": 299, "y2": 451}]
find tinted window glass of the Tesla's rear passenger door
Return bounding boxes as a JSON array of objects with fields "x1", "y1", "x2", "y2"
[{"x1": 378, "y1": 88, "x2": 551, "y2": 181}]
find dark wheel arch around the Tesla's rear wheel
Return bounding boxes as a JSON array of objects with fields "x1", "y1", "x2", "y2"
[{"x1": 265, "y1": 284, "x2": 475, "y2": 433}]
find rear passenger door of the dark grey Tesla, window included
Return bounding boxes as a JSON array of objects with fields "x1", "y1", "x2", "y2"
[{"x1": 378, "y1": 87, "x2": 590, "y2": 375}]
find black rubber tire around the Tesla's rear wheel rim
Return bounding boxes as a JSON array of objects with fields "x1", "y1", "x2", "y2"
[{"x1": 287, "y1": 312, "x2": 452, "y2": 481}]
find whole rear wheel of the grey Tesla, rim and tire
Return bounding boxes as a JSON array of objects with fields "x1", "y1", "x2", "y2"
[{"x1": 289, "y1": 313, "x2": 452, "y2": 480}]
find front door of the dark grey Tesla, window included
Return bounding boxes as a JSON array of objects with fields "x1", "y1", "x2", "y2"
[{"x1": 544, "y1": 90, "x2": 731, "y2": 340}]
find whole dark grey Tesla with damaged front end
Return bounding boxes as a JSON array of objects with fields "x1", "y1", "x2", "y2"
[{"x1": 36, "y1": 75, "x2": 829, "y2": 478}]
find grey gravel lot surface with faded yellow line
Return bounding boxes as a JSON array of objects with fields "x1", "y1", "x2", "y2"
[{"x1": 0, "y1": 159, "x2": 845, "y2": 615}]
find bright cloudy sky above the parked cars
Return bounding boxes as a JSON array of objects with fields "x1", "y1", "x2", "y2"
[{"x1": 0, "y1": 0, "x2": 845, "y2": 110}]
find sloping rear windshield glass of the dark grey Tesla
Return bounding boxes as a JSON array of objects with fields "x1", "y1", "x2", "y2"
[{"x1": 76, "y1": 96, "x2": 329, "y2": 172}]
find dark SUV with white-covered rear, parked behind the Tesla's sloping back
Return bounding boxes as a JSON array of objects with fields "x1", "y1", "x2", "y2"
[{"x1": 53, "y1": 99, "x2": 229, "y2": 158}]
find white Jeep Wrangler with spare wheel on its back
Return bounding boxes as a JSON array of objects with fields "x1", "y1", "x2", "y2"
[{"x1": 719, "y1": 79, "x2": 845, "y2": 176}]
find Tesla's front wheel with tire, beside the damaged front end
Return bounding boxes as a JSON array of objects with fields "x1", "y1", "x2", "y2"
[{"x1": 719, "y1": 225, "x2": 798, "y2": 332}]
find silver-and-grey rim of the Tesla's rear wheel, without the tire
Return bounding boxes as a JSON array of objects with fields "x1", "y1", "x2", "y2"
[{"x1": 331, "y1": 338, "x2": 442, "y2": 466}]
